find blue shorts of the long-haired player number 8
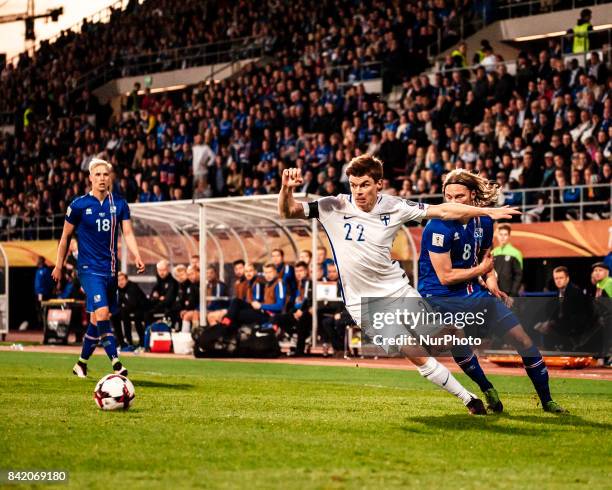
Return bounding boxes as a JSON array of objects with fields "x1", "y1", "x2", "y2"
[{"x1": 425, "y1": 286, "x2": 521, "y2": 337}]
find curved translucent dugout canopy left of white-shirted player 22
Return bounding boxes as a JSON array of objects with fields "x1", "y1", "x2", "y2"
[{"x1": 130, "y1": 193, "x2": 318, "y2": 275}]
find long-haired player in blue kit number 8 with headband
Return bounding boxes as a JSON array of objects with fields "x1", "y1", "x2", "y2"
[{"x1": 418, "y1": 169, "x2": 566, "y2": 413}]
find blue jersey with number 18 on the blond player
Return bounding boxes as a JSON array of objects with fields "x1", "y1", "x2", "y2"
[{"x1": 66, "y1": 193, "x2": 130, "y2": 276}]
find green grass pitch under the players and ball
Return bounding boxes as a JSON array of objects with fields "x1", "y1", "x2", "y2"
[{"x1": 0, "y1": 352, "x2": 612, "y2": 489}]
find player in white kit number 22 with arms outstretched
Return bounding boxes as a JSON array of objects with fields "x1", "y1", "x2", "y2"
[{"x1": 278, "y1": 155, "x2": 520, "y2": 415}]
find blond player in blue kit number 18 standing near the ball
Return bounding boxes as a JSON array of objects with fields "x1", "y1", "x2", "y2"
[{"x1": 52, "y1": 158, "x2": 144, "y2": 378}]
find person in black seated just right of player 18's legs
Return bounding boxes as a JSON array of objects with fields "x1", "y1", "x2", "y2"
[{"x1": 112, "y1": 272, "x2": 149, "y2": 351}]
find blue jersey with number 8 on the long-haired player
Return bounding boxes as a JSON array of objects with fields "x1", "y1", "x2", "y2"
[{"x1": 418, "y1": 216, "x2": 493, "y2": 296}]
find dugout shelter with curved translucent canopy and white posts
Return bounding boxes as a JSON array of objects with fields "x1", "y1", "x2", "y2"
[{"x1": 125, "y1": 193, "x2": 418, "y2": 345}]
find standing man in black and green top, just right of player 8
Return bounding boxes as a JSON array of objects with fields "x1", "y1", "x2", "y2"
[{"x1": 492, "y1": 223, "x2": 523, "y2": 297}]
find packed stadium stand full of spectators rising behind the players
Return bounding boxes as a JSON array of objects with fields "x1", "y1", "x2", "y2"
[{"x1": 0, "y1": 0, "x2": 612, "y2": 239}]
